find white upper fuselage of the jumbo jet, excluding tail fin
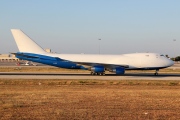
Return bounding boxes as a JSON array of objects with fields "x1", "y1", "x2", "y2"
[{"x1": 40, "y1": 53, "x2": 174, "y2": 69}]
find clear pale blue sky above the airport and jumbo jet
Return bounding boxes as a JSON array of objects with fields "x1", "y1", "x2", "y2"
[{"x1": 0, "y1": 0, "x2": 180, "y2": 56}]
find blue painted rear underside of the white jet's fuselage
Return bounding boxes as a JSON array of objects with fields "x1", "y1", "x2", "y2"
[{"x1": 16, "y1": 52, "x2": 85, "y2": 69}]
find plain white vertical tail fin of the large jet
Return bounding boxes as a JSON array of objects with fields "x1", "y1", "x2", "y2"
[{"x1": 11, "y1": 29, "x2": 45, "y2": 53}]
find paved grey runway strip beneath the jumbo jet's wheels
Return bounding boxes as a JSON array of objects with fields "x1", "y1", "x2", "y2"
[{"x1": 0, "y1": 72, "x2": 180, "y2": 80}]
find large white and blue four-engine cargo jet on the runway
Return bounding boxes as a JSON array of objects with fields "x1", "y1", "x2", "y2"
[{"x1": 11, "y1": 29, "x2": 174, "y2": 75}]
